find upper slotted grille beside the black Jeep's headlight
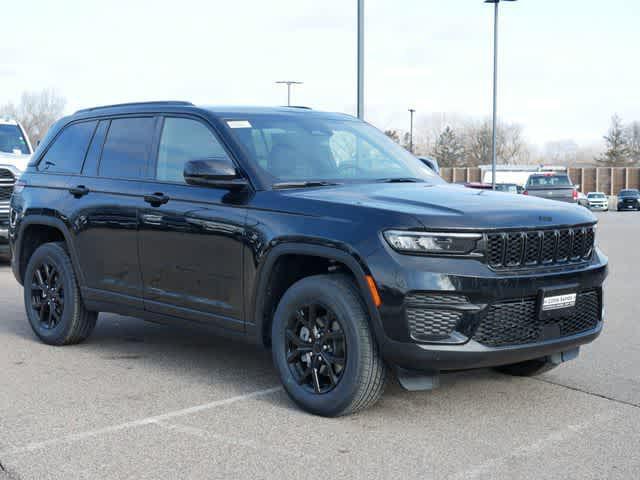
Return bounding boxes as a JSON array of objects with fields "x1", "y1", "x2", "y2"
[{"x1": 486, "y1": 227, "x2": 595, "y2": 270}]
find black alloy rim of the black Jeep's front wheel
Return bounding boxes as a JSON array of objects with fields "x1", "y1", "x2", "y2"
[{"x1": 285, "y1": 303, "x2": 347, "y2": 394}]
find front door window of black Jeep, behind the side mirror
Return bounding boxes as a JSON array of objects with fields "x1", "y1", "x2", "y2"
[{"x1": 156, "y1": 117, "x2": 231, "y2": 182}]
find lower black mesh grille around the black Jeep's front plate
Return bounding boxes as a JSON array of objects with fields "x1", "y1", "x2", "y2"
[{"x1": 473, "y1": 290, "x2": 601, "y2": 347}]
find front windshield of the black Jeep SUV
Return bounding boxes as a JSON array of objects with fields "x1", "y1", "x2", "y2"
[{"x1": 226, "y1": 113, "x2": 444, "y2": 184}]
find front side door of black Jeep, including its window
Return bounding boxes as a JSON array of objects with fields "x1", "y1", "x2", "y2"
[{"x1": 140, "y1": 116, "x2": 247, "y2": 330}]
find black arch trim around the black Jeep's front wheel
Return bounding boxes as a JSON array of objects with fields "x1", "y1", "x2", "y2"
[{"x1": 248, "y1": 243, "x2": 383, "y2": 347}]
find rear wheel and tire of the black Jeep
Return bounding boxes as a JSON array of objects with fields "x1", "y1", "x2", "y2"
[{"x1": 24, "y1": 243, "x2": 98, "y2": 345}]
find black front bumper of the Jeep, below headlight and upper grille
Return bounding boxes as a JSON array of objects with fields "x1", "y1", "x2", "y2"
[{"x1": 372, "y1": 251, "x2": 608, "y2": 372}]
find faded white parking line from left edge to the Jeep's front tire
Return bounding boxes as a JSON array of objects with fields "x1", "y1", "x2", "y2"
[{"x1": 0, "y1": 387, "x2": 282, "y2": 457}]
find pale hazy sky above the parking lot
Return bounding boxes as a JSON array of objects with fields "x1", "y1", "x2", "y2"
[{"x1": 0, "y1": 0, "x2": 640, "y2": 145}]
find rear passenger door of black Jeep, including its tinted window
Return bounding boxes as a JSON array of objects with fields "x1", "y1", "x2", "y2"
[{"x1": 69, "y1": 116, "x2": 159, "y2": 309}]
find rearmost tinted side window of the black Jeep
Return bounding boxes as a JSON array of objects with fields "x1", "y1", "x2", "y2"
[{"x1": 38, "y1": 122, "x2": 97, "y2": 173}]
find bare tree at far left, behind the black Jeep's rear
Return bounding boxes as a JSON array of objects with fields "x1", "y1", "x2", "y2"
[{"x1": 0, "y1": 89, "x2": 67, "y2": 145}]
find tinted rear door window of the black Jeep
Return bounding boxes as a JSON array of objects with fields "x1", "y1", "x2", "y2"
[{"x1": 100, "y1": 117, "x2": 156, "y2": 178}]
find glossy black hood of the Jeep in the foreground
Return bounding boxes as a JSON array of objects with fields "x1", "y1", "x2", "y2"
[{"x1": 286, "y1": 183, "x2": 596, "y2": 230}]
